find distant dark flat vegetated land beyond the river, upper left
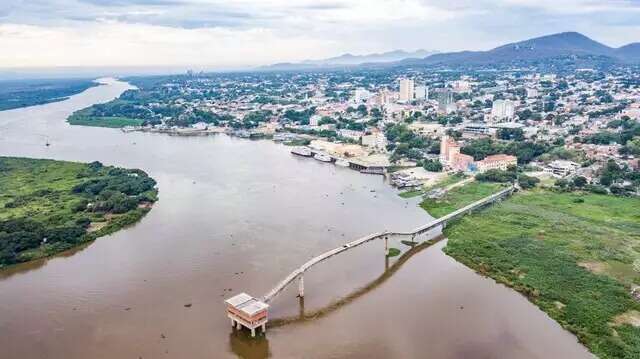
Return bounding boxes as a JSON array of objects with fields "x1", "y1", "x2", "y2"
[{"x1": 0, "y1": 79, "x2": 98, "y2": 111}]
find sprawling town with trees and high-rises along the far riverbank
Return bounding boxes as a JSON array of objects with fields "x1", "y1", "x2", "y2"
[{"x1": 75, "y1": 68, "x2": 640, "y2": 194}]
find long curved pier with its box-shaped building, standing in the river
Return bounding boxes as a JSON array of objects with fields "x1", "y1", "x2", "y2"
[{"x1": 226, "y1": 186, "x2": 515, "y2": 335}]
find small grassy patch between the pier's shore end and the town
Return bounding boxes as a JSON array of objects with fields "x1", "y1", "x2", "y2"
[{"x1": 420, "y1": 181, "x2": 504, "y2": 218}]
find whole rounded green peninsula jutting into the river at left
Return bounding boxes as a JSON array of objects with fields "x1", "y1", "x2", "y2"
[{"x1": 0, "y1": 157, "x2": 157, "y2": 268}]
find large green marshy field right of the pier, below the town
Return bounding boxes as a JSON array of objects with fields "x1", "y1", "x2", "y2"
[{"x1": 445, "y1": 190, "x2": 640, "y2": 358}]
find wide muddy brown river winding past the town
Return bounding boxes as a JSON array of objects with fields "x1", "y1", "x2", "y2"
[{"x1": 0, "y1": 80, "x2": 591, "y2": 359}]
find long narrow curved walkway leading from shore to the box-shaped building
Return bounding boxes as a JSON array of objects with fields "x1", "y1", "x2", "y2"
[{"x1": 262, "y1": 187, "x2": 514, "y2": 303}]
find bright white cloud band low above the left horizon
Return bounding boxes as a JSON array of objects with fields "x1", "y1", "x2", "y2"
[{"x1": 0, "y1": 22, "x2": 336, "y2": 67}]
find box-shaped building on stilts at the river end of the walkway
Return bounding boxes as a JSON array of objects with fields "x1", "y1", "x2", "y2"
[{"x1": 224, "y1": 293, "x2": 269, "y2": 337}]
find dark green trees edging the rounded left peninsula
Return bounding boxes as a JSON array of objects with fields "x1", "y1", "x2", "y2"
[{"x1": 0, "y1": 161, "x2": 156, "y2": 267}]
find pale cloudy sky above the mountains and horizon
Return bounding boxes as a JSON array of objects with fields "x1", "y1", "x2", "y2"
[{"x1": 0, "y1": 0, "x2": 640, "y2": 69}]
